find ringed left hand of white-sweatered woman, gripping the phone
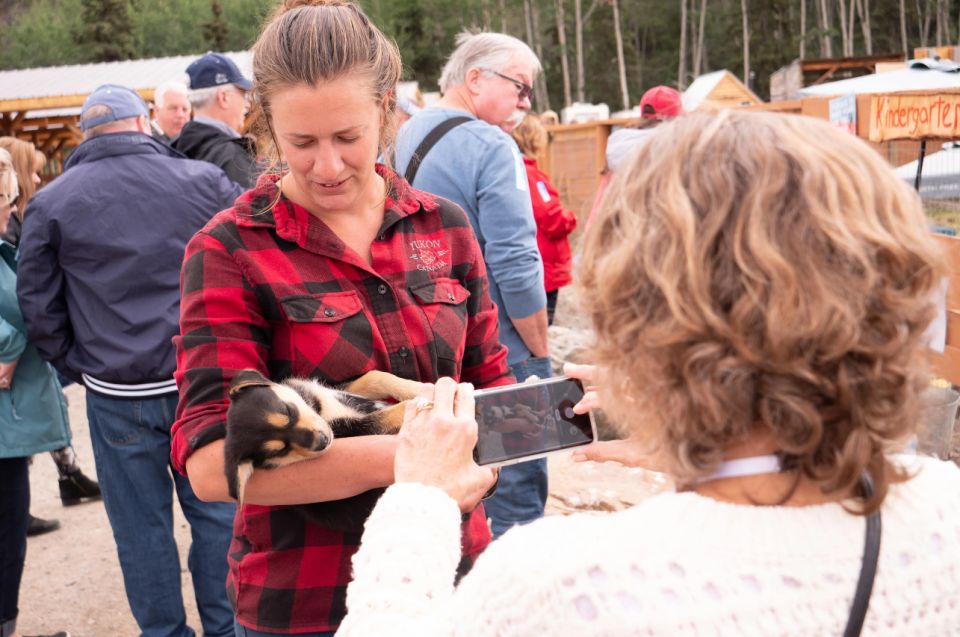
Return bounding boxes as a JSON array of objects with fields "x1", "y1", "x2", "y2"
[{"x1": 394, "y1": 378, "x2": 495, "y2": 512}]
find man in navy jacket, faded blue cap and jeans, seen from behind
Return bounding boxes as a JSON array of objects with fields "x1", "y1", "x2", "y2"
[{"x1": 17, "y1": 84, "x2": 240, "y2": 637}]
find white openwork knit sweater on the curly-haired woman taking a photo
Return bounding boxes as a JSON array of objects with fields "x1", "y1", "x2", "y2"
[{"x1": 337, "y1": 458, "x2": 960, "y2": 637}]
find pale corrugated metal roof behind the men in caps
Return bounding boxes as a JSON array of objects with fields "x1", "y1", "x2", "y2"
[{"x1": 0, "y1": 51, "x2": 253, "y2": 102}]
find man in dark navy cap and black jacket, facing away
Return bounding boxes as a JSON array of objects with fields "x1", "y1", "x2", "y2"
[{"x1": 173, "y1": 53, "x2": 259, "y2": 189}]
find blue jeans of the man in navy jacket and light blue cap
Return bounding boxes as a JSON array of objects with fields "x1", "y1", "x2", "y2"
[{"x1": 87, "y1": 391, "x2": 236, "y2": 637}]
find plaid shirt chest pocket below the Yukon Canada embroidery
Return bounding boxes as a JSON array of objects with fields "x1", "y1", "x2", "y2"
[{"x1": 409, "y1": 278, "x2": 470, "y2": 378}]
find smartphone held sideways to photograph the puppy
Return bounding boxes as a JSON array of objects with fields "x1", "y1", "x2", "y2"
[{"x1": 473, "y1": 376, "x2": 597, "y2": 467}]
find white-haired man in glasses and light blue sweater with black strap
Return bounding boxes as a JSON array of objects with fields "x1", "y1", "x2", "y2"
[{"x1": 396, "y1": 33, "x2": 552, "y2": 537}]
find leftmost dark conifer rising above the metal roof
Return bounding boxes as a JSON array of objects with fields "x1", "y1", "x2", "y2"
[{"x1": 76, "y1": 0, "x2": 137, "y2": 62}]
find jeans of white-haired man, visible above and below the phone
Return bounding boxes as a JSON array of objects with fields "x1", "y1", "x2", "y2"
[{"x1": 483, "y1": 358, "x2": 553, "y2": 539}]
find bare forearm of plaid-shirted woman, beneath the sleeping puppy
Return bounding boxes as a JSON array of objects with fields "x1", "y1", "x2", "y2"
[{"x1": 186, "y1": 436, "x2": 396, "y2": 505}]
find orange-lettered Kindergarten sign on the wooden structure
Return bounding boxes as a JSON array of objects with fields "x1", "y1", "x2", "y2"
[{"x1": 870, "y1": 93, "x2": 960, "y2": 142}]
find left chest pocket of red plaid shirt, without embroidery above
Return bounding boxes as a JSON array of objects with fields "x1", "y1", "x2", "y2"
[{"x1": 274, "y1": 290, "x2": 374, "y2": 378}]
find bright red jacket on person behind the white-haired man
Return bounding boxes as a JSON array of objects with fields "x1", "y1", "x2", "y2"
[{"x1": 523, "y1": 157, "x2": 577, "y2": 292}]
